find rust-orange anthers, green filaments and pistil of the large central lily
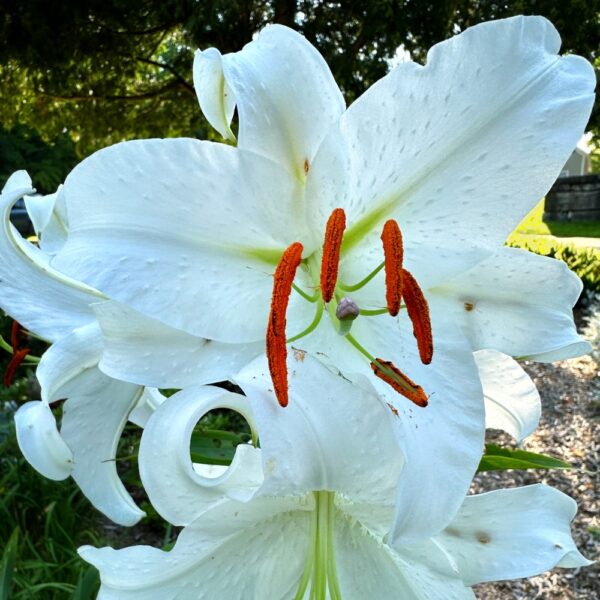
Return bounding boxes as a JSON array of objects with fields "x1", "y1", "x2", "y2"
[{"x1": 267, "y1": 208, "x2": 433, "y2": 406}]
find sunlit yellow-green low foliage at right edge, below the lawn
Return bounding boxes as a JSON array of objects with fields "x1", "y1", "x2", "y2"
[{"x1": 508, "y1": 235, "x2": 600, "y2": 292}]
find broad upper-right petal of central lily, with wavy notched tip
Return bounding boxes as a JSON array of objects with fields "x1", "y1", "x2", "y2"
[{"x1": 307, "y1": 17, "x2": 596, "y2": 285}]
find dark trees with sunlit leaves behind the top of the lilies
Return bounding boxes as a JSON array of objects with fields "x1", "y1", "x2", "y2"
[{"x1": 0, "y1": 0, "x2": 600, "y2": 156}]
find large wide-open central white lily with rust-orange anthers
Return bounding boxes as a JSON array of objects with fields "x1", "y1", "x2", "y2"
[{"x1": 48, "y1": 17, "x2": 595, "y2": 533}]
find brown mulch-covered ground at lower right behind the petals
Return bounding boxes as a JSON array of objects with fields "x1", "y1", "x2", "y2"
[{"x1": 473, "y1": 356, "x2": 600, "y2": 600}]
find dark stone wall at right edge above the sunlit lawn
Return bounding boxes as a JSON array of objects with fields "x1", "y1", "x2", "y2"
[{"x1": 544, "y1": 173, "x2": 600, "y2": 221}]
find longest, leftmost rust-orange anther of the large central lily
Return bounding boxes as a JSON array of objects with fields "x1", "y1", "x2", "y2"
[{"x1": 267, "y1": 242, "x2": 304, "y2": 406}]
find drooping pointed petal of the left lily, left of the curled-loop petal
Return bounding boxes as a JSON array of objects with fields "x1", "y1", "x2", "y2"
[{"x1": 37, "y1": 323, "x2": 145, "y2": 525}]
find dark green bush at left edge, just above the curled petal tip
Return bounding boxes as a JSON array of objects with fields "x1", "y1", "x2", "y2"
[{"x1": 0, "y1": 125, "x2": 78, "y2": 194}]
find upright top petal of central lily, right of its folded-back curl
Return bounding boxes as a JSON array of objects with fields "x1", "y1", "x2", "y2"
[{"x1": 222, "y1": 25, "x2": 345, "y2": 181}]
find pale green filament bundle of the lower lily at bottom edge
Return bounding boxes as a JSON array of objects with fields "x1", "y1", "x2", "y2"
[{"x1": 294, "y1": 491, "x2": 342, "y2": 600}]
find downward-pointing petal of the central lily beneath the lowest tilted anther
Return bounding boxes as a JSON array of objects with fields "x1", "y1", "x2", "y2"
[{"x1": 296, "y1": 298, "x2": 485, "y2": 542}]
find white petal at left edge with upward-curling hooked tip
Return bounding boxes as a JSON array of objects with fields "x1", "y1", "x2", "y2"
[{"x1": 0, "y1": 171, "x2": 102, "y2": 341}]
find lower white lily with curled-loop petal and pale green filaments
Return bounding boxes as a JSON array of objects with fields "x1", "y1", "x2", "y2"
[{"x1": 79, "y1": 356, "x2": 589, "y2": 600}]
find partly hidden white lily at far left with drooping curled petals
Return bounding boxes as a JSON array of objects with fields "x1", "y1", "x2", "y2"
[{"x1": 0, "y1": 171, "x2": 144, "y2": 525}]
